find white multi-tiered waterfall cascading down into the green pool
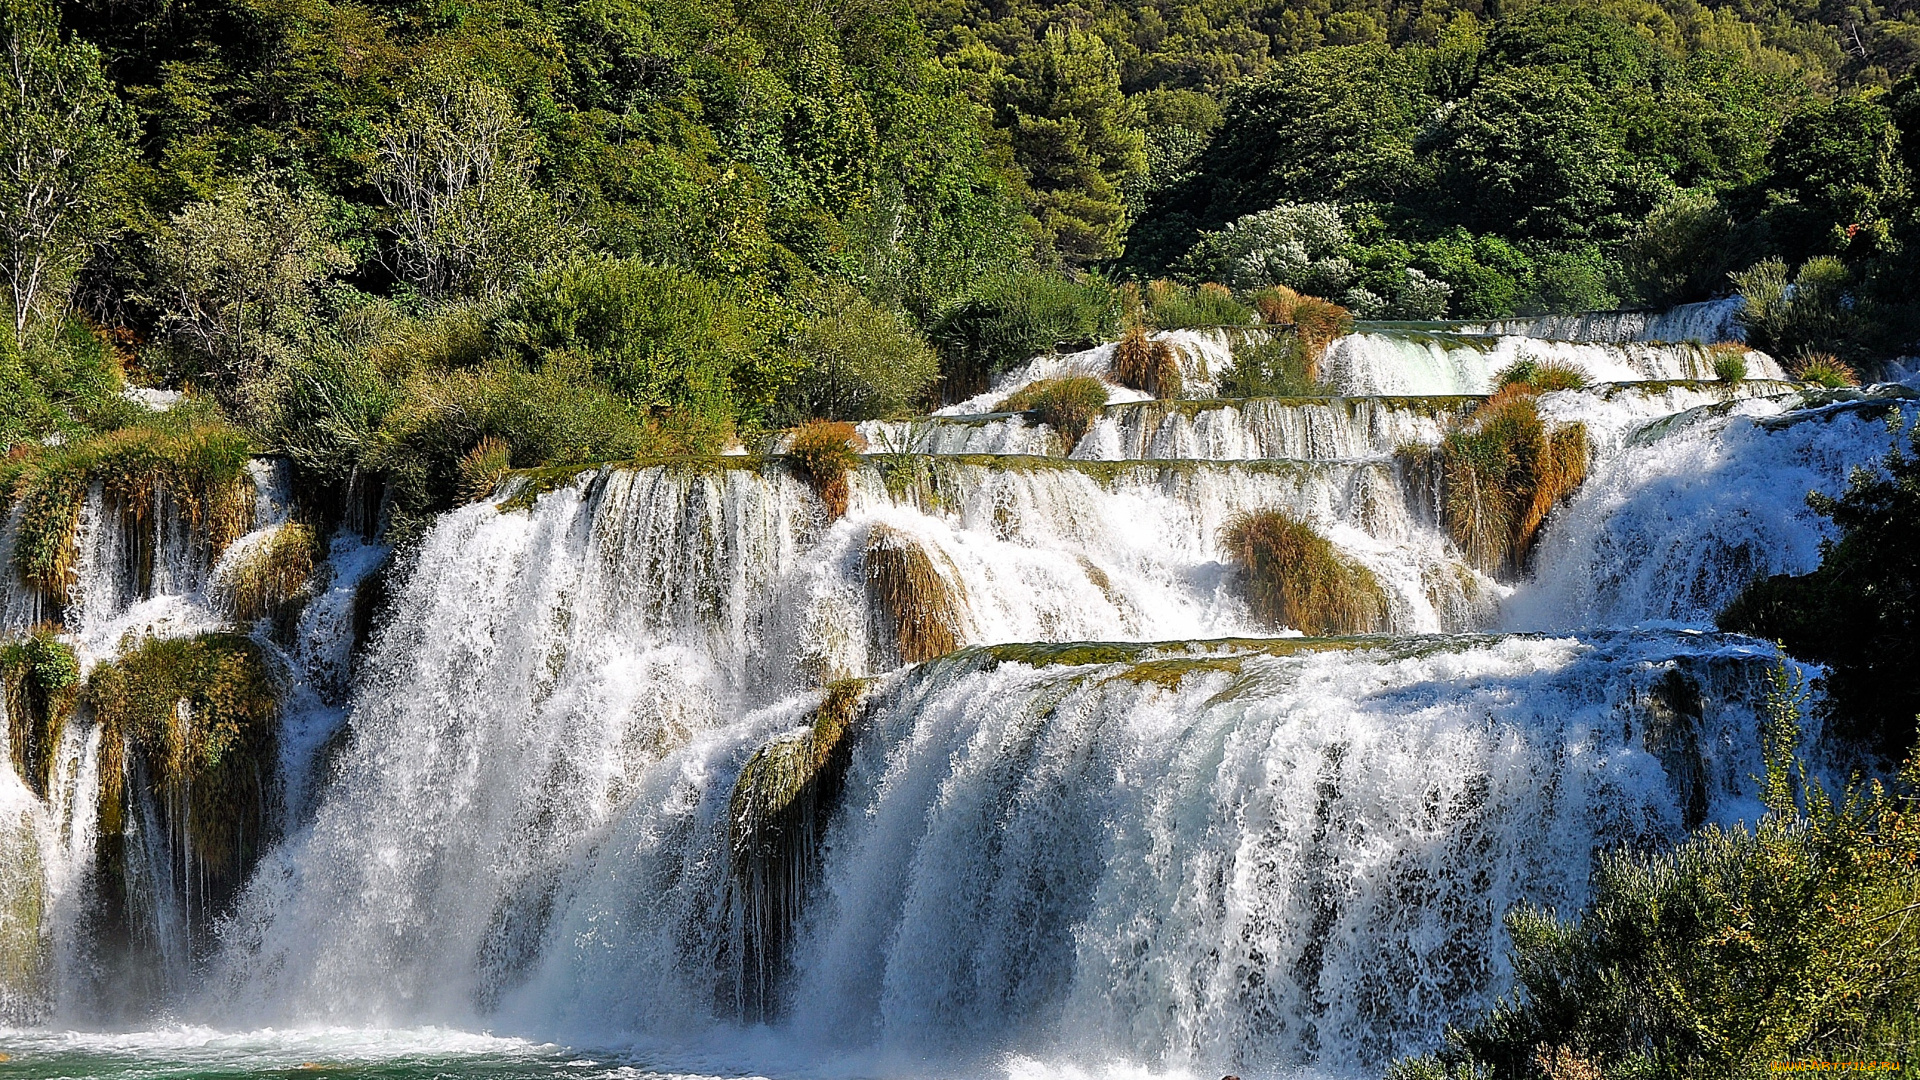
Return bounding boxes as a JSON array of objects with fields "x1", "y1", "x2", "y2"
[{"x1": 0, "y1": 311, "x2": 1912, "y2": 1078}]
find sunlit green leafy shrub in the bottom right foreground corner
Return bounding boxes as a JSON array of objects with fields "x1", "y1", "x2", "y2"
[{"x1": 1392, "y1": 673, "x2": 1920, "y2": 1078}]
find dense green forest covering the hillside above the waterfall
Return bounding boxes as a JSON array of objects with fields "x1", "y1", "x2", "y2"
[{"x1": 0, "y1": 0, "x2": 1920, "y2": 523}]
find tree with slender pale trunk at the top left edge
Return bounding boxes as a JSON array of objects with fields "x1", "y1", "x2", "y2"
[{"x1": 0, "y1": 0, "x2": 134, "y2": 338}]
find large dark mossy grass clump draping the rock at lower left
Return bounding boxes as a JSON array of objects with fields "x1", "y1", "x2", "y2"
[{"x1": 84, "y1": 634, "x2": 280, "y2": 903}]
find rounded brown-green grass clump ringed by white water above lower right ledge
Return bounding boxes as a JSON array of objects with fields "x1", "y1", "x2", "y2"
[{"x1": 1221, "y1": 509, "x2": 1386, "y2": 636}]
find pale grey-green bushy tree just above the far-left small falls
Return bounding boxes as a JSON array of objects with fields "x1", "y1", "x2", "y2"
[{"x1": 146, "y1": 173, "x2": 351, "y2": 411}]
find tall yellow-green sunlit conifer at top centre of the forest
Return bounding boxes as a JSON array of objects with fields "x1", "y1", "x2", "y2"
[{"x1": 1000, "y1": 27, "x2": 1146, "y2": 265}]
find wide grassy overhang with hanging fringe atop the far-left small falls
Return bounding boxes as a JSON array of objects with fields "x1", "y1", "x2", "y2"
[{"x1": 8, "y1": 407, "x2": 253, "y2": 596}]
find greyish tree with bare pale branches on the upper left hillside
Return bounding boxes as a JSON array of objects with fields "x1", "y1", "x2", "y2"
[{"x1": 372, "y1": 73, "x2": 572, "y2": 298}]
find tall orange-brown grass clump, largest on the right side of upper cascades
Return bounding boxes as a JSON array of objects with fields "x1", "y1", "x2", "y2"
[{"x1": 1438, "y1": 386, "x2": 1588, "y2": 573}]
